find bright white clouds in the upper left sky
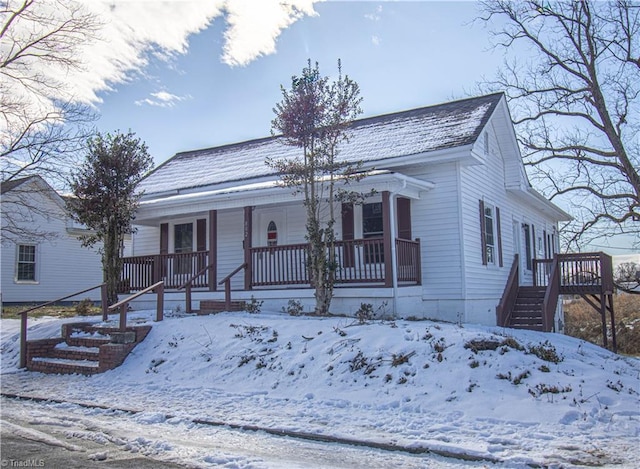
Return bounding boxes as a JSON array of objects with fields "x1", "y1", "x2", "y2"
[{"x1": 0, "y1": 0, "x2": 321, "y2": 134}]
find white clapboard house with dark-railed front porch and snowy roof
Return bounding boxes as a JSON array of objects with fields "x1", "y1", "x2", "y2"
[{"x1": 122, "y1": 93, "x2": 596, "y2": 330}]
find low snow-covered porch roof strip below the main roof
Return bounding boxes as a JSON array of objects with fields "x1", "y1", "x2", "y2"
[{"x1": 135, "y1": 171, "x2": 435, "y2": 225}]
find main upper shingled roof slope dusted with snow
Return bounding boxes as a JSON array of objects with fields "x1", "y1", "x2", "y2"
[{"x1": 140, "y1": 93, "x2": 503, "y2": 194}]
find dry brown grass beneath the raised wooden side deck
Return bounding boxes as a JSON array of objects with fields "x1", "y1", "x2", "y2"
[{"x1": 564, "y1": 293, "x2": 640, "y2": 356}]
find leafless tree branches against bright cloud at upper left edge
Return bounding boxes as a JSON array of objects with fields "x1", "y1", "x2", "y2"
[{"x1": 0, "y1": 0, "x2": 100, "y2": 239}]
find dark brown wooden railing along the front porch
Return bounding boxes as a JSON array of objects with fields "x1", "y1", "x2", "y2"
[{"x1": 119, "y1": 237, "x2": 421, "y2": 293}]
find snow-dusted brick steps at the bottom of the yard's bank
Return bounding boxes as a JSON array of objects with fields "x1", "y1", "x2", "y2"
[{"x1": 27, "y1": 323, "x2": 151, "y2": 375}]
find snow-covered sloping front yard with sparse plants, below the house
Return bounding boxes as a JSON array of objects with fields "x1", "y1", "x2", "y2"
[{"x1": 0, "y1": 312, "x2": 640, "y2": 468}]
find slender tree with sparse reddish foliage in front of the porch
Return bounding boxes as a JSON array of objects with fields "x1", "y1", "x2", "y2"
[{"x1": 267, "y1": 61, "x2": 365, "y2": 315}]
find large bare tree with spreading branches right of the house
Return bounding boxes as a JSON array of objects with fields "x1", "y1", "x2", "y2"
[{"x1": 481, "y1": 0, "x2": 640, "y2": 249}]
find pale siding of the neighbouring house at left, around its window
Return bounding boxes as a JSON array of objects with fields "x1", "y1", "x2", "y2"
[{"x1": 1, "y1": 183, "x2": 102, "y2": 303}]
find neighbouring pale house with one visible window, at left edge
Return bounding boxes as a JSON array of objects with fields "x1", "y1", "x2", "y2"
[{"x1": 0, "y1": 176, "x2": 102, "y2": 305}]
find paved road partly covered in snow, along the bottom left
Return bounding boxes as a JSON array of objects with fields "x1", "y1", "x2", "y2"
[{"x1": 0, "y1": 397, "x2": 470, "y2": 469}]
